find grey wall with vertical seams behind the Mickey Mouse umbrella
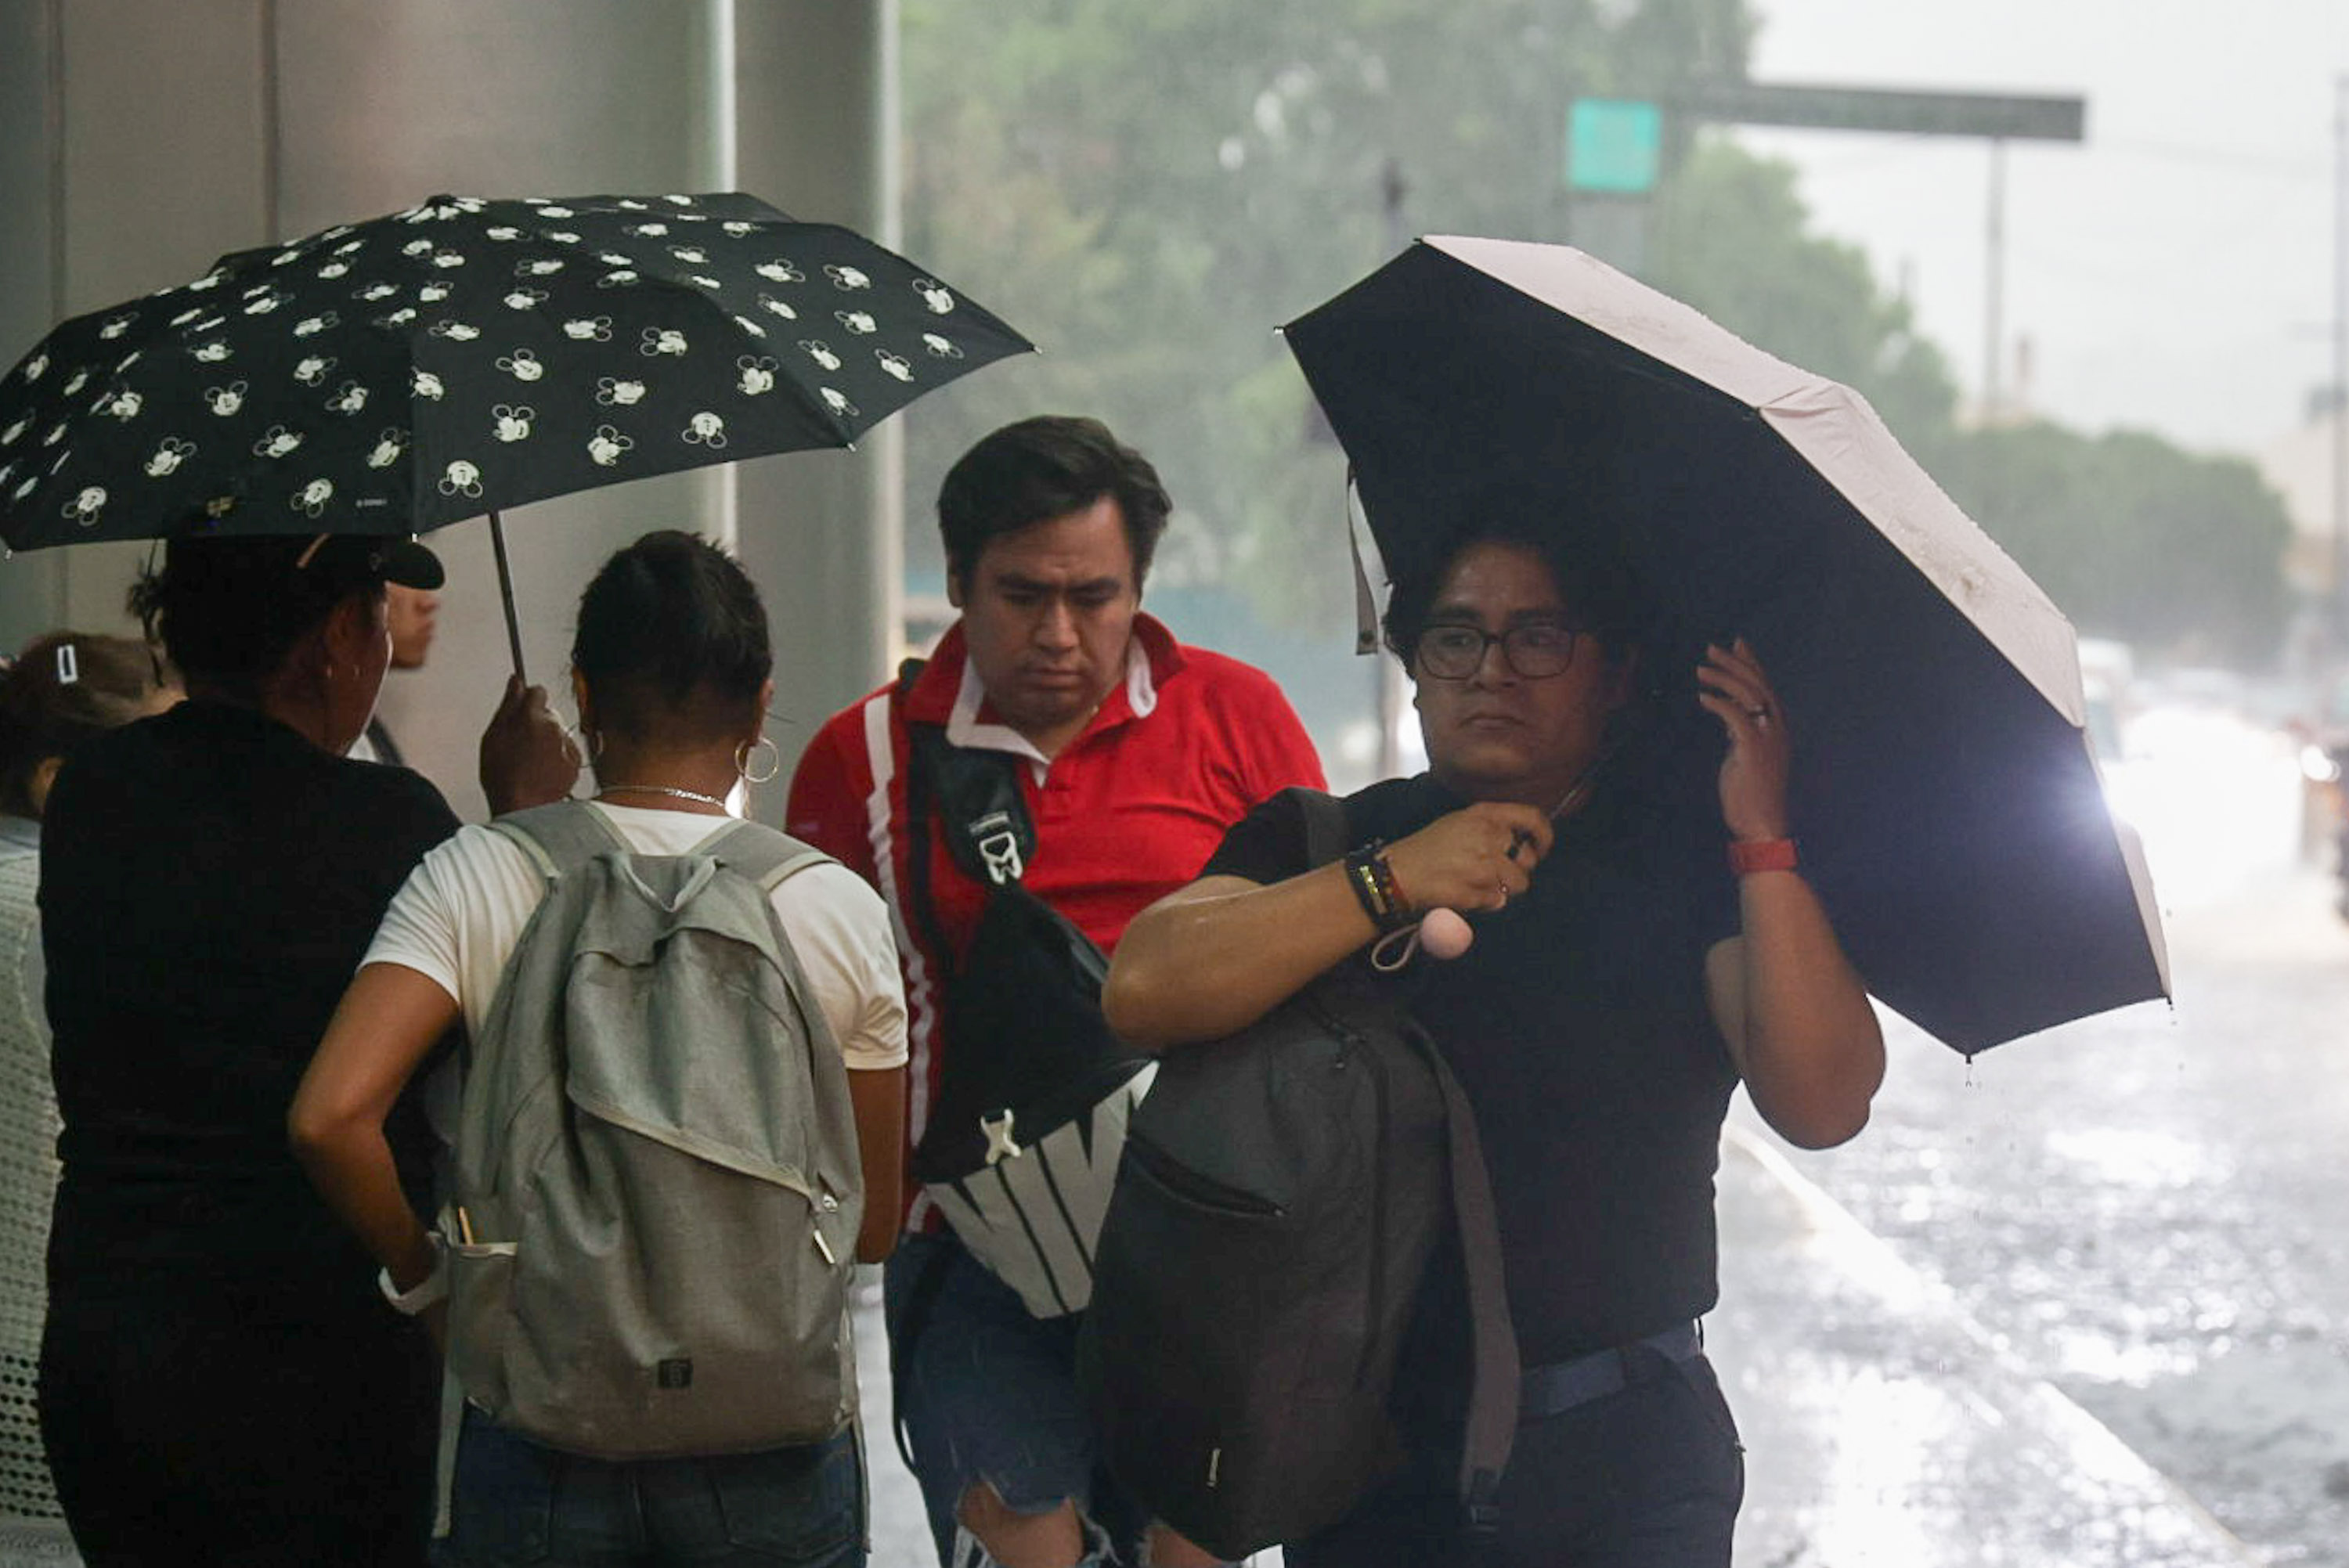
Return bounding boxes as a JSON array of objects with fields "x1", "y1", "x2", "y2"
[{"x1": 0, "y1": 0, "x2": 900, "y2": 816}]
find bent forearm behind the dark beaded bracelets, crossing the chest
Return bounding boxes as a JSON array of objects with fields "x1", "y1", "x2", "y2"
[{"x1": 1102, "y1": 866, "x2": 1377, "y2": 1051}]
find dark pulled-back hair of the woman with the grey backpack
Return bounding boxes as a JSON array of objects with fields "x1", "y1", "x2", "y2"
[{"x1": 571, "y1": 528, "x2": 775, "y2": 744}]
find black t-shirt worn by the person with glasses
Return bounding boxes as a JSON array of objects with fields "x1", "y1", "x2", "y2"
[{"x1": 1203, "y1": 775, "x2": 1738, "y2": 1366}]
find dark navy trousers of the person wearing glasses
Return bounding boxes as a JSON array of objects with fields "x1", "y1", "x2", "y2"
[{"x1": 1287, "y1": 1350, "x2": 1745, "y2": 1568}]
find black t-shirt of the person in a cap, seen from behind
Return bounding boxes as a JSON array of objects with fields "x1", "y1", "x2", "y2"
[{"x1": 40, "y1": 702, "x2": 456, "y2": 1321}]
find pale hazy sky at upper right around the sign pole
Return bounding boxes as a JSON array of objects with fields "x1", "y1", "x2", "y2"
[{"x1": 1741, "y1": 0, "x2": 2349, "y2": 451}]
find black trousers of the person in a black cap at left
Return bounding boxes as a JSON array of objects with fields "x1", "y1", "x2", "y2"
[{"x1": 40, "y1": 1296, "x2": 439, "y2": 1568}]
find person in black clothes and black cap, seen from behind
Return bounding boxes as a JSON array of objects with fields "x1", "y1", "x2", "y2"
[{"x1": 40, "y1": 535, "x2": 456, "y2": 1568}]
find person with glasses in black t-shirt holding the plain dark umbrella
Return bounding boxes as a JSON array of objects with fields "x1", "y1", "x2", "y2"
[{"x1": 1104, "y1": 528, "x2": 1884, "y2": 1568}]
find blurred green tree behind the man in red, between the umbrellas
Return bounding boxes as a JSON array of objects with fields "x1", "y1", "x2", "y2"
[{"x1": 904, "y1": 0, "x2": 1672, "y2": 622}]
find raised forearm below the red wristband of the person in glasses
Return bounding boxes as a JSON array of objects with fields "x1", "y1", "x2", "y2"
[{"x1": 1738, "y1": 871, "x2": 1884, "y2": 1148}]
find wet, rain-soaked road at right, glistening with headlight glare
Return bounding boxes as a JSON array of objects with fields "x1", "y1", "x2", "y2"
[{"x1": 1766, "y1": 714, "x2": 2349, "y2": 1563}]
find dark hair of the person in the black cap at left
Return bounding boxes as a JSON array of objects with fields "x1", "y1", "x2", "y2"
[{"x1": 129, "y1": 533, "x2": 383, "y2": 702}]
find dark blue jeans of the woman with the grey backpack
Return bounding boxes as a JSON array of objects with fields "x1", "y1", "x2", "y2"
[{"x1": 432, "y1": 1406, "x2": 864, "y2": 1568}]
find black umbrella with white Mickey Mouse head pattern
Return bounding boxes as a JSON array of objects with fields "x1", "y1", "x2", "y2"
[{"x1": 0, "y1": 193, "x2": 1034, "y2": 661}]
